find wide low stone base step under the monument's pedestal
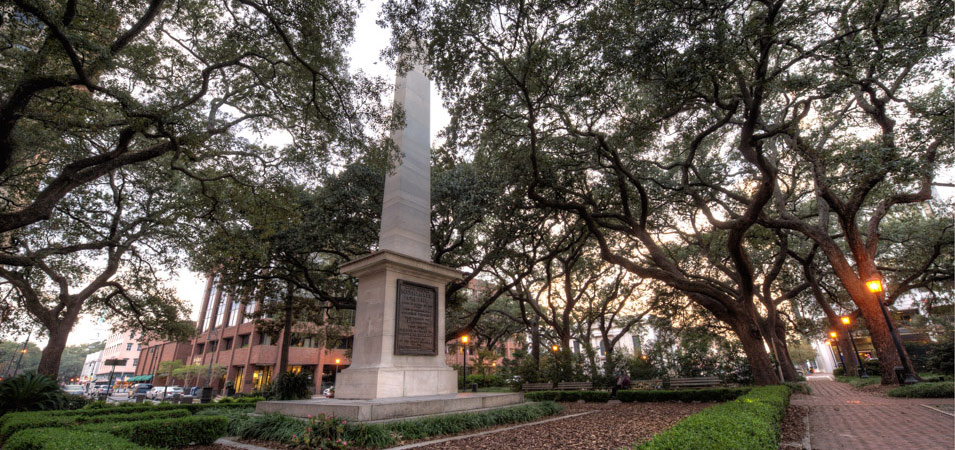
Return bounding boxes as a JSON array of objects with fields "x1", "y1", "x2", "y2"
[{"x1": 255, "y1": 392, "x2": 524, "y2": 422}]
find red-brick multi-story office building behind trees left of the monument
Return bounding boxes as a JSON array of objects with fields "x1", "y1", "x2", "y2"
[{"x1": 137, "y1": 277, "x2": 352, "y2": 393}]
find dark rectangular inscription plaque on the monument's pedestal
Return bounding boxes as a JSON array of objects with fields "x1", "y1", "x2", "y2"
[{"x1": 395, "y1": 280, "x2": 438, "y2": 356}]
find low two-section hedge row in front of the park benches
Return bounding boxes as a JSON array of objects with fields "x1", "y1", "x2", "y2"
[{"x1": 524, "y1": 388, "x2": 750, "y2": 403}]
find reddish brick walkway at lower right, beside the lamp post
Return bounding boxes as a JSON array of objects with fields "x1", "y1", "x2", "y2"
[{"x1": 791, "y1": 376, "x2": 955, "y2": 450}]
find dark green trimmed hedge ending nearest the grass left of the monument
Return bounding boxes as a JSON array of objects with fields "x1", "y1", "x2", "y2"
[{"x1": 78, "y1": 416, "x2": 229, "y2": 447}]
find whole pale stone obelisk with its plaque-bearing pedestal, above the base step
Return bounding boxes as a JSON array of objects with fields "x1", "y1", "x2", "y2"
[{"x1": 335, "y1": 61, "x2": 461, "y2": 399}]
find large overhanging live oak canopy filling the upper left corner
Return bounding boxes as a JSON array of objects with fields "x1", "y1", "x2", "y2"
[{"x1": 0, "y1": 0, "x2": 384, "y2": 236}]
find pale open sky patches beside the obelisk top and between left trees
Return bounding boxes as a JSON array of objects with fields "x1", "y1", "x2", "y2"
[{"x1": 54, "y1": 0, "x2": 450, "y2": 347}]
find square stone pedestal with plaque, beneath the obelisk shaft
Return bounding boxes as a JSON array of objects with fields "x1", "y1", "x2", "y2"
[{"x1": 335, "y1": 250, "x2": 461, "y2": 399}]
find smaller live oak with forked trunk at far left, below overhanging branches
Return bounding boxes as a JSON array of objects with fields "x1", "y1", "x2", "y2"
[{"x1": 0, "y1": 162, "x2": 191, "y2": 377}]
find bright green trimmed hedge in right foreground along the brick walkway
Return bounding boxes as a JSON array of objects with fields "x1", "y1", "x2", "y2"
[{"x1": 636, "y1": 386, "x2": 792, "y2": 450}]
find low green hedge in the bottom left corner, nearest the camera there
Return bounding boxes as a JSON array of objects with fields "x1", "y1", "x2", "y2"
[{"x1": 3, "y1": 428, "x2": 147, "y2": 450}]
